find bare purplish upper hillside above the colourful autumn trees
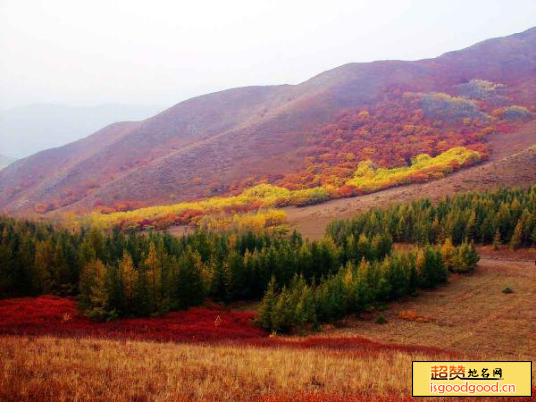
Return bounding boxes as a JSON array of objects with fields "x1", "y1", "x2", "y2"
[{"x1": 0, "y1": 28, "x2": 536, "y2": 212}]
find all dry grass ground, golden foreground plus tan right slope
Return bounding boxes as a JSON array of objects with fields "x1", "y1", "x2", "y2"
[{"x1": 0, "y1": 252, "x2": 536, "y2": 401}]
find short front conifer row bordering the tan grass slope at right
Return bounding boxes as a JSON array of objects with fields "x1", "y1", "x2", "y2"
[{"x1": 259, "y1": 242, "x2": 479, "y2": 332}]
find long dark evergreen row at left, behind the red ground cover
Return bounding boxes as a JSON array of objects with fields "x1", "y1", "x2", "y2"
[{"x1": 0, "y1": 218, "x2": 392, "y2": 319}]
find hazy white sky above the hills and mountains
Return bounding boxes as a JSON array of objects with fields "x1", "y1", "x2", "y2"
[{"x1": 0, "y1": 0, "x2": 536, "y2": 108}]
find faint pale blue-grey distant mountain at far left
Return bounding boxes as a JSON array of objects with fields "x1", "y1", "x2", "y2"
[{"x1": 0, "y1": 104, "x2": 160, "y2": 157}]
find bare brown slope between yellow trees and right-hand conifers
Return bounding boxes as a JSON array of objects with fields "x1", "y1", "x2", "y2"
[{"x1": 292, "y1": 122, "x2": 536, "y2": 239}]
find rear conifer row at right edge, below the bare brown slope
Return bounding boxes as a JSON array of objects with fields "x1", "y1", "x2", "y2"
[{"x1": 327, "y1": 186, "x2": 536, "y2": 249}]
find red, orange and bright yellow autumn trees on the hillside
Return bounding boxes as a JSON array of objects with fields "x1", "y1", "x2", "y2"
[{"x1": 50, "y1": 79, "x2": 535, "y2": 230}]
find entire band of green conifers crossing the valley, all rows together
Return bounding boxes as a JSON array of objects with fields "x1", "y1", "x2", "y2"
[{"x1": 4, "y1": 187, "x2": 536, "y2": 332}]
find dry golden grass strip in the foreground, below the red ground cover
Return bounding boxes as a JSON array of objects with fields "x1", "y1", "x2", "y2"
[{"x1": 0, "y1": 337, "x2": 444, "y2": 401}]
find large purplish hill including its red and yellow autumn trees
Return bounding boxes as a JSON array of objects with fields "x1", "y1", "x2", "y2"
[{"x1": 0, "y1": 28, "x2": 536, "y2": 215}]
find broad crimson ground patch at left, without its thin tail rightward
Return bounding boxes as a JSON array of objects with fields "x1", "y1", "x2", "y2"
[{"x1": 0, "y1": 296, "x2": 267, "y2": 342}]
